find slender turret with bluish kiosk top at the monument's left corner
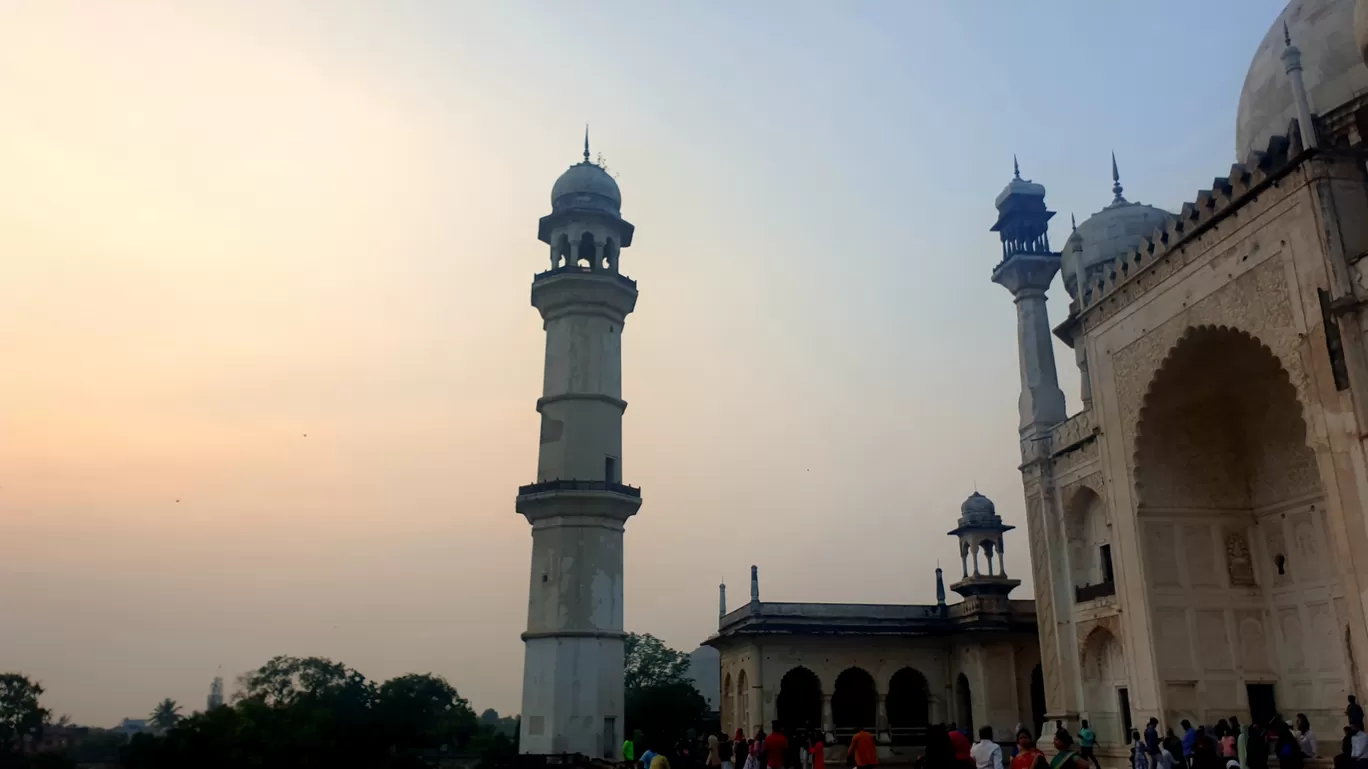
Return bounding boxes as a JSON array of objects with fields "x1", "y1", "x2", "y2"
[{"x1": 992, "y1": 157, "x2": 1067, "y2": 438}]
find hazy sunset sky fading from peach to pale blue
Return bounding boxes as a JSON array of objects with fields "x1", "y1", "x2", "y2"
[{"x1": 0, "y1": 0, "x2": 1282, "y2": 725}]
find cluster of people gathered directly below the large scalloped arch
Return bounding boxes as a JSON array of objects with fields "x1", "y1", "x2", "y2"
[{"x1": 1127, "y1": 695, "x2": 1368, "y2": 769}]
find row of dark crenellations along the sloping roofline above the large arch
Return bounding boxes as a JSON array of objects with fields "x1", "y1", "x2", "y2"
[{"x1": 1079, "y1": 122, "x2": 1305, "y2": 313}]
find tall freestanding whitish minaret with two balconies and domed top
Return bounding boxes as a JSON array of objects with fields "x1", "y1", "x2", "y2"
[{"x1": 517, "y1": 130, "x2": 642, "y2": 759}]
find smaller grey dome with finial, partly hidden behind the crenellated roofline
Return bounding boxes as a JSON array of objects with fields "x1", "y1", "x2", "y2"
[{"x1": 1060, "y1": 155, "x2": 1174, "y2": 297}]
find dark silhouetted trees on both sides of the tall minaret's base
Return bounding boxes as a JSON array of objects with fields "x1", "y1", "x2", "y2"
[{"x1": 0, "y1": 634, "x2": 707, "y2": 769}]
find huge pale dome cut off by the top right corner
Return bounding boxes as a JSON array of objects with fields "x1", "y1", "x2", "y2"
[{"x1": 1235, "y1": 0, "x2": 1368, "y2": 163}]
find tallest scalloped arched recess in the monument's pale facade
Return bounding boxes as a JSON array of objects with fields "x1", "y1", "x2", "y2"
[{"x1": 1132, "y1": 327, "x2": 1347, "y2": 721}]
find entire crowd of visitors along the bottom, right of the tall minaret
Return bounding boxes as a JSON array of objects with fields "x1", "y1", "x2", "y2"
[{"x1": 622, "y1": 696, "x2": 1368, "y2": 769}]
